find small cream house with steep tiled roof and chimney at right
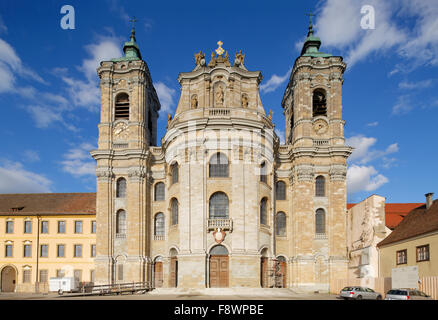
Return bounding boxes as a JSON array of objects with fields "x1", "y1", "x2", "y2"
[{"x1": 377, "y1": 193, "x2": 438, "y2": 278}]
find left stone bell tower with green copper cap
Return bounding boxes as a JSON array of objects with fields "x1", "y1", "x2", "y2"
[{"x1": 91, "y1": 27, "x2": 160, "y2": 284}]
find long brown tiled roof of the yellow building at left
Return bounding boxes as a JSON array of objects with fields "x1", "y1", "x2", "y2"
[{"x1": 0, "y1": 193, "x2": 96, "y2": 216}]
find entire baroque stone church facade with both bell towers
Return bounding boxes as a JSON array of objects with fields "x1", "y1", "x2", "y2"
[{"x1": 91, "y1": 20, "x2": 352, "y2": 291}]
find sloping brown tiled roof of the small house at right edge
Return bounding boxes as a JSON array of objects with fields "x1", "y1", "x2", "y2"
[{"x1": 377, "y1": 200, "x2": 438, "y2": 247}]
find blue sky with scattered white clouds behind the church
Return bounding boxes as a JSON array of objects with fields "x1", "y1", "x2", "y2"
[{"x1": 0, "y1": 0, "x2": 438, "y2": 202}]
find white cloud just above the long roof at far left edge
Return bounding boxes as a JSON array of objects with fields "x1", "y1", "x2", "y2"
[{"x1": 0, "y1": 160, "x2": 52, "y2": 193}]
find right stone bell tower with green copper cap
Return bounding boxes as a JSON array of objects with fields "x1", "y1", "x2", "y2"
[{"x1": 282, "y1": 17, "x2": 352, "y2": 291}]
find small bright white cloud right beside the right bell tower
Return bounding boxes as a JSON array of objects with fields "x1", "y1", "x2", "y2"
[{"x1": 347, "y1": 165, "x2": 389, "y2": 194}]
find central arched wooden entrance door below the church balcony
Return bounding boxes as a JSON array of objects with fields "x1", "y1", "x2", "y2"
[{"x1": 210, "y1": 246, "x2": 229, "y2": 288}]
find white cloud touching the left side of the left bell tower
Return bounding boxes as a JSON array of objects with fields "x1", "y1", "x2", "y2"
[{"x1": 61, "y1": 143, "x2": 96, "y2": 177}]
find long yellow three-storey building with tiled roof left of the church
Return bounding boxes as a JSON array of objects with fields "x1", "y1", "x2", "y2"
[{"x1": 0, "y1": 193, "x2": 96, "y2": 292}]
